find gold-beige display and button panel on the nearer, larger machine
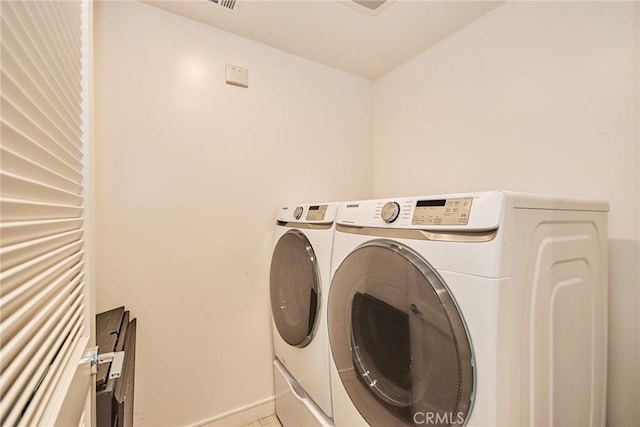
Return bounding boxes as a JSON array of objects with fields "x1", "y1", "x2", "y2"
[{"x1": 411, "y1": 197, "x2": 473, "y2": 225}]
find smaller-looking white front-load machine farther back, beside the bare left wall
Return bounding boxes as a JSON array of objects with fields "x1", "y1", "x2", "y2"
[{"x1": 270, "y1": 203, "x2": 337, "y2": 427}]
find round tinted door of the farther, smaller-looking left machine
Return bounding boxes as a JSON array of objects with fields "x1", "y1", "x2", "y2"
[{"x1": 270, "y1": 230, "x2": 320, "y2": 347}]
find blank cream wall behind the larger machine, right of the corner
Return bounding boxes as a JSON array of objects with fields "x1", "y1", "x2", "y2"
[{"x1": 373, "y1": 2, "x2": 640, "y2": 426}]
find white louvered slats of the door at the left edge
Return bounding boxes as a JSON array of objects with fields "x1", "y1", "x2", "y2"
[{"x1": 0, "y1": 1, "x2": 88, "y2": 426}]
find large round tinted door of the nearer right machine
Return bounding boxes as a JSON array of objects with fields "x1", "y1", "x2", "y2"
[{"x1": 328, "y1": 240, "x2": 474, "y2": 427}]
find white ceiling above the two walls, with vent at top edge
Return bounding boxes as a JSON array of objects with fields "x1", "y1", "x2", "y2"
[{"x1": 145, "y1": 0, "x2": 503, "y2": 80}]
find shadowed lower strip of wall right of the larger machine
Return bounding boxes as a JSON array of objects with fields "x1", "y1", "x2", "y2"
[{"x1": 607, "y1": 239, "x2": 640, "y2": 426}]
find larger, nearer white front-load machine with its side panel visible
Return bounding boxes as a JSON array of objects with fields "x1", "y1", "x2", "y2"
[{"x1": 328, "y1": 192, "x2": 608, "y2": 427}]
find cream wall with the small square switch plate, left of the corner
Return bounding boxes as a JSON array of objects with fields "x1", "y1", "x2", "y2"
[{"x1": 94, "y1": 2, "x2": 372, "y2": 426}]
